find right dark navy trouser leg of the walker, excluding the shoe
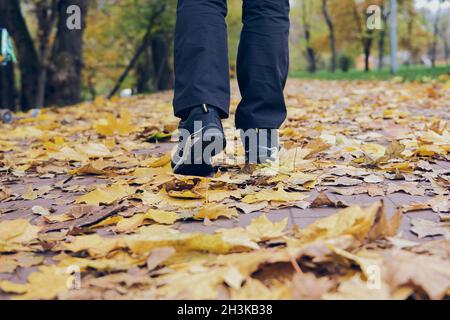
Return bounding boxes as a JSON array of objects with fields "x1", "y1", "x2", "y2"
[{"x1": 236, "y1": 0, "x2": 289, "y2": 130}]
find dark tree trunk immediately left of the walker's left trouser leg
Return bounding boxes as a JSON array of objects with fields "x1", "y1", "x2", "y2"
[{"x1": 152, "y1": 34, "x2": 174, "y2": 91}]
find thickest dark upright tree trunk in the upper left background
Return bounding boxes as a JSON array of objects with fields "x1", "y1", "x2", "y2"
[{"x1": 46, "y1": 0, "x2": 88, "y2": 106}]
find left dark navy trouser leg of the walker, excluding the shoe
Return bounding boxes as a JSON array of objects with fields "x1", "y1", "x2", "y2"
[{"x1": 173, "y1": 0, "x2": 230, "y2": 120}]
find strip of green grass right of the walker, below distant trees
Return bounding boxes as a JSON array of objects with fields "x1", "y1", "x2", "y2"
[{"x1": 290, "y1": 65, "x2": 450, "y2": 81}]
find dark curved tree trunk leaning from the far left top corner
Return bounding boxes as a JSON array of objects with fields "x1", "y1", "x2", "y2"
[{"x1": 0, "y1": 0, "x2": 39, "y2": 111}]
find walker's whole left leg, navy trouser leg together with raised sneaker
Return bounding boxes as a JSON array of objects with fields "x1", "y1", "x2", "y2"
[{"x1": 172, "y1": 0, "x2": 230, "y2": 176}]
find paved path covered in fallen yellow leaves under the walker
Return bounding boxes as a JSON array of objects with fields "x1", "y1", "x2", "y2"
[{"x1": 0, "y1": 80, "x2": 450, "y2": 299}]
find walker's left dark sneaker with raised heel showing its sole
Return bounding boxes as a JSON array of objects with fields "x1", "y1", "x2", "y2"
[{"x1": 172, "y1": 105, "x2": 226, "y2": 177}]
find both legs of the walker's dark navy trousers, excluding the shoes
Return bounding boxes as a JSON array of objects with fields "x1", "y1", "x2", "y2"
[{"x1": 174, "y1": 0, "x2": 289, "y2": 130}]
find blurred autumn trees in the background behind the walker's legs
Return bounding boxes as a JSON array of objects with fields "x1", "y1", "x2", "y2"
[{"x1": 0, "y1": 0, "x2": 450, "y2": 110}]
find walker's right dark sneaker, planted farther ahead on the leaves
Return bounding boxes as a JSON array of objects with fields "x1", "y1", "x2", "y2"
[{"x1": 241, "y1": 129, "x2": 280, "y2": 164}]
